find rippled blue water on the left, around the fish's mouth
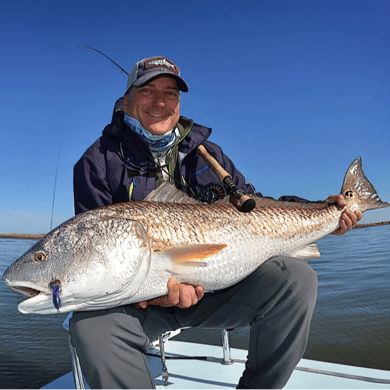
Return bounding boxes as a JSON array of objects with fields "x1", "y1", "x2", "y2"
[{"x1": 0, "y1": 238, "x2": 71, "y2": 389}]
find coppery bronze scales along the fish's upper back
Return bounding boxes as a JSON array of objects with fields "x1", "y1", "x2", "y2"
[{"x1": 105, "y1": 200, "x2": 336, "y2": 247}]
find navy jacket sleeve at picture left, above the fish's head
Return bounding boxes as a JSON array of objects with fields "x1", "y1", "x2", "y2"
[{"x1": 73, "y1": 151, "x2": 113, "y2": 215}]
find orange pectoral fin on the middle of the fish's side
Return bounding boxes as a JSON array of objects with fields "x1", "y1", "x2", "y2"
[{"x1": 163, "y1": 244, "x2": 227, "y2": 267}]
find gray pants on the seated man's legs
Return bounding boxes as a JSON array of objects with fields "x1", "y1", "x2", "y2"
[{"x1": 70, "y1": 257, "x2": 318, "y2": 389}]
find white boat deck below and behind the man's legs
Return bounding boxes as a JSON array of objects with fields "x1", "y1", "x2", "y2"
[{"x1": 42, "y1": 340, "x2": 390, "y2": 390}]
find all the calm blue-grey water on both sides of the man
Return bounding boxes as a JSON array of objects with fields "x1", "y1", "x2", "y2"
[{"x1": 0, "y1": 226, "x2": 390, "y2": 389}]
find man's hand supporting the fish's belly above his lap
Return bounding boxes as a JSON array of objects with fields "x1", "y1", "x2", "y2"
[{"x1": 135, "y1": 276, "x2": 204, "y2": 309}]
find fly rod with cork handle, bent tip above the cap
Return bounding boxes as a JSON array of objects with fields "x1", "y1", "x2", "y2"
[{"x1": 79, "y1": 45, "x2": 256, "y2": 212}]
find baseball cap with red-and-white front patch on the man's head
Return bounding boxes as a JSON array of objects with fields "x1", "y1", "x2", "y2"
[{"x1": 126, "y1": 57, "x2": 188, "y2": 92}]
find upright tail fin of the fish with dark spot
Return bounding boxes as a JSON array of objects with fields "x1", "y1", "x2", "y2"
[{"x1": 341, "y1": 157, "x2": 390, "y2": 212}]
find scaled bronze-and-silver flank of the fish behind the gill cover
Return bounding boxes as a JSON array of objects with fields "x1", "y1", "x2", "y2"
[{"x1": 93, "y1": 201, "x2": 341, "y2": 301}]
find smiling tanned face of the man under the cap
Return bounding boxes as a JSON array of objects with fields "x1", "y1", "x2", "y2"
[{"x1": 123, "y1": 76, "x2": 180, "y2": 135}]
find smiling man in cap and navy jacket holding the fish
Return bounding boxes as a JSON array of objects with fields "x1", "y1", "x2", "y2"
[{"x1": 70, "y1": 57, "x2": 362, "y2": 389}]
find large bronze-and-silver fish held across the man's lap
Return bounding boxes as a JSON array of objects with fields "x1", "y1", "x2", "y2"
[{"x1": 3, "y1": 158, "x2": 390, "y2": 314}]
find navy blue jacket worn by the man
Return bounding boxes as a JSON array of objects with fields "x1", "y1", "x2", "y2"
[{"x1": 73, "y1": 98, "x2": 310, "y2": 214}]
